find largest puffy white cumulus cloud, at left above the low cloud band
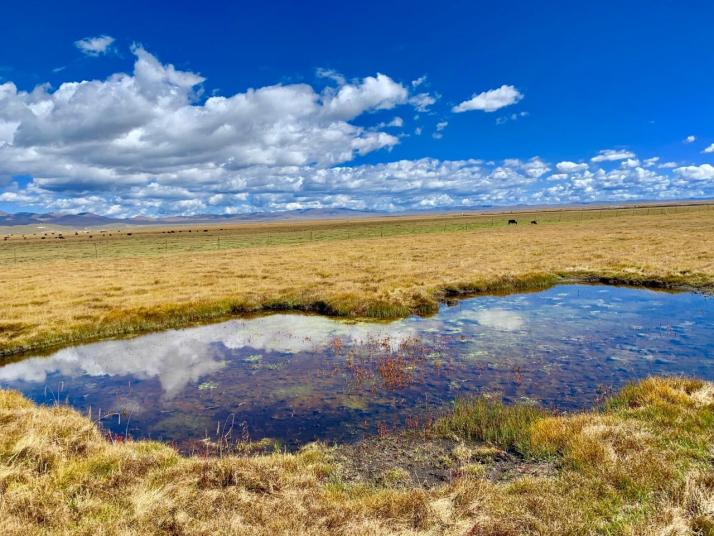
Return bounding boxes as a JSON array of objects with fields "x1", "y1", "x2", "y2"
[{"x1": 0, "y1": 48, "x2": 408, "y2": 203}]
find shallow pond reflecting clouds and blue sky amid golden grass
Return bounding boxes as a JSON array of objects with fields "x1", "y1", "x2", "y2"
[{"x1": 0, "y1": 285, "x2": 714, "y2": 450}]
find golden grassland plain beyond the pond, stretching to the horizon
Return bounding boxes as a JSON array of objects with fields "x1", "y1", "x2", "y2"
[{"x1": 0, "y1": 205, "x2": 714, "y2": 356}]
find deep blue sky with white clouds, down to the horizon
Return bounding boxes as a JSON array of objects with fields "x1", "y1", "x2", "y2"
[{"x1": 0, "y1": 1, "x2": 714, "y2": 216}]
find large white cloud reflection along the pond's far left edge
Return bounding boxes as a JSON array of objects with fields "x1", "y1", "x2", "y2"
[{"x1": 0, "y1": 315, "x2": 416, "y2": 398}]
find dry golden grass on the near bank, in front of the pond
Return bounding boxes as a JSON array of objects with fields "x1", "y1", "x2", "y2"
[{"x1": 0, "y1": 379, "x2": 714, "y2": 536}]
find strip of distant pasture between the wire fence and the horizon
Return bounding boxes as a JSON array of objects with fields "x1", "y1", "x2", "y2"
[{"x1": 0, "y1": 204, "x2": 714, "y2": 266}]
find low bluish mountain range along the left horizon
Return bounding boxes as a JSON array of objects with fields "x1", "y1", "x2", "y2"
[{"x1": 0, "y1": 208, "x2": 383, "y2": 227}]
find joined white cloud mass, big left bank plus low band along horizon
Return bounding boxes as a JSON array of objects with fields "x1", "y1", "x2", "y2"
[{"x1": 0, "y1": 47, "x2": 714, "y2": 216}]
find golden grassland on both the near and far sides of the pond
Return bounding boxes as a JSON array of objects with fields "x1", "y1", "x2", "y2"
[{"x1": 0, "y1": 205, "x2": 714, "y2": 536}]
